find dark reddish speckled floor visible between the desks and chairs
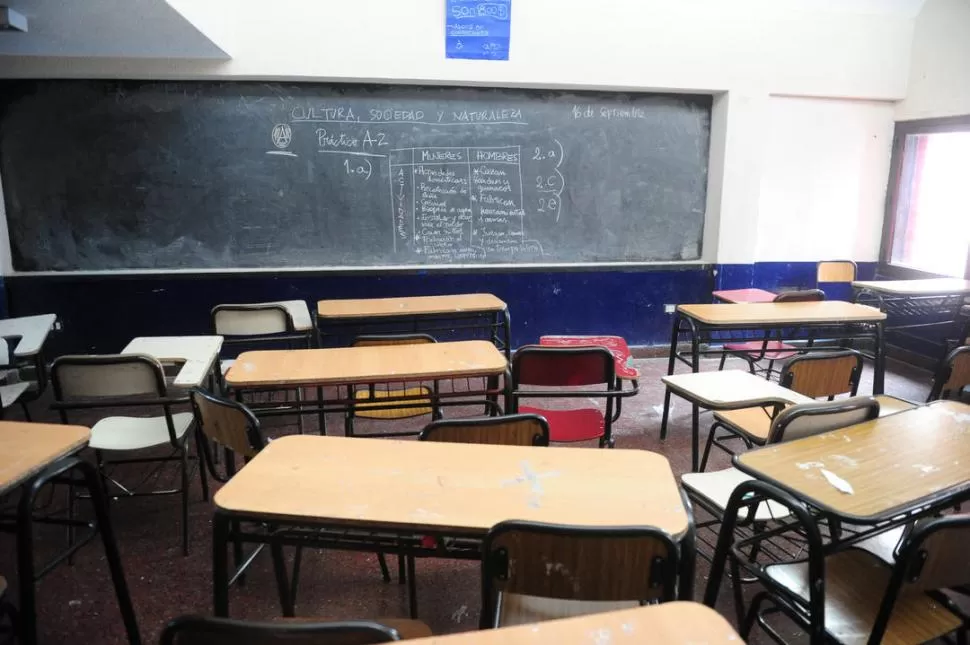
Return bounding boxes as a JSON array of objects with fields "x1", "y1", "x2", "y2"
[{"x1": 0, "y1": 359, "x2": 930, "y2": 645}]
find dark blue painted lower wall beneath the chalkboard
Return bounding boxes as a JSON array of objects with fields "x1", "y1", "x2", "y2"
[{"x1": 3, "y1": 262, "x2": 875, "y2": 355}]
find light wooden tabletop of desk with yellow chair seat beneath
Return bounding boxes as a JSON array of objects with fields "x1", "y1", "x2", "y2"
[{"x1": 226, "y1": 340, "x2": 508, "y2": 389}]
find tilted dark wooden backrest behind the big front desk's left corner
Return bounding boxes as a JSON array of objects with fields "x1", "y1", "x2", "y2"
[{"x1": 189, "y1": 388, "x2": 266, "y2": 457}]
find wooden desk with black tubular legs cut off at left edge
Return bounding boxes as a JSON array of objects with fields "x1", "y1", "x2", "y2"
[{"x1": 0, "y1": 421, "x2": 140, "y2": 645}]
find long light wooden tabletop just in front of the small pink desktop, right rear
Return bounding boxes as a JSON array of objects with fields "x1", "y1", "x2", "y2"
[{"x1": 677, "y1": 300, "x2": 886, "y2": 326}]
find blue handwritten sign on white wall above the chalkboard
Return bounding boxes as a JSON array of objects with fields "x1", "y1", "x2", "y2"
[{"x1": 445, "y1": 0, "x2": 512, "y2": 60}]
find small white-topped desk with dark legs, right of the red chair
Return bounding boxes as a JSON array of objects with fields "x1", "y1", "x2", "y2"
[{"x1": 660, "y1": 370, "x2": 812, "y2": 472}]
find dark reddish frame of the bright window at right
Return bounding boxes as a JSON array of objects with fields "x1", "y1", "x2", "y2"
[{"x1": 879, "y1": 114, "x2": 970, "y2": 280}]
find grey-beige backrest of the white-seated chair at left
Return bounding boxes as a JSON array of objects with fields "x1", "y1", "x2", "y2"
[{"x1": 51, "y1": 354, "x2": 166, "y2": 401}]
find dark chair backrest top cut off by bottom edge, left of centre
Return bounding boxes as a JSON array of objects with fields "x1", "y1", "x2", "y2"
[{"x1": 160, "y1": 616, "x2": 400, "y2": 645}]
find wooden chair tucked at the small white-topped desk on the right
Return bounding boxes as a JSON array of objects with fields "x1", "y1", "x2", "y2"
[{"x1": 700, "y1": 349, "x2": 862, "y2": 471}]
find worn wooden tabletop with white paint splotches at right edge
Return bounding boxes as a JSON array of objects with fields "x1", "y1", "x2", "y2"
[{"x1": 734, "y1": 401, "x2": 970, "y2": 523}]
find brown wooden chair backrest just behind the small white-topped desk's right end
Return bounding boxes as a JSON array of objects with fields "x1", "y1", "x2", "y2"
[{"x1": 780, "y1": 349, "x2": 862, "y2": 399}]
